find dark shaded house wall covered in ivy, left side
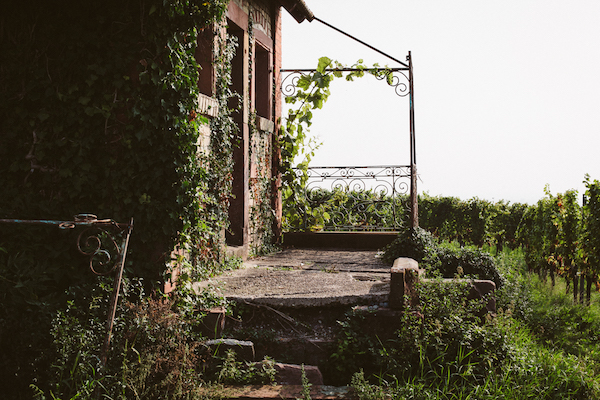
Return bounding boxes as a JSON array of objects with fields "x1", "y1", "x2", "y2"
[{"x1": 0, "y1": 0, "x2": 236, "y2": 285}]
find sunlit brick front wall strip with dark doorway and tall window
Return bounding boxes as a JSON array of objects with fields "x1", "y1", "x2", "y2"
[{"x1": 227, "y1": 0, "x2": 281, "y2": 255}]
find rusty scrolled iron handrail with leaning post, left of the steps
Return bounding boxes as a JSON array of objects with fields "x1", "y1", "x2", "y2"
[{"x1": 0, "y1": 214, "x2": 133, "y2": 366}]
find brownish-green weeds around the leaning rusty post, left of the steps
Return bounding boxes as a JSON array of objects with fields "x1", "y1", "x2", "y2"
[{"x1": 28, "y1": 281, "x2": 232, "y2": 399}]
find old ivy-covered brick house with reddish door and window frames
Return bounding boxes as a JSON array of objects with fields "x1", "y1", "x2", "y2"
[{"x1": 0, "y1": 0, "x2": 313, "y2": 285}]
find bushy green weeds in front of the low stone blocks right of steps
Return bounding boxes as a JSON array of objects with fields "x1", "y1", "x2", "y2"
[{"x1": 394, "y1": 280, "x2": 509, "y2": 379}]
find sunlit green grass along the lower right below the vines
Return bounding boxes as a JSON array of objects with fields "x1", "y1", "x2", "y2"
[{"x1": 352, "y1": 250, "x2": 600, "y2": 400}]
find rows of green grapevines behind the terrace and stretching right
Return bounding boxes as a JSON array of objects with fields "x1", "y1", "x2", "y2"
[{"x1": 284, "y1": 177, "x2": 600, "y2": 303}]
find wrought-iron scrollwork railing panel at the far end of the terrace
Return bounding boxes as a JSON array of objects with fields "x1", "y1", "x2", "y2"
[{"x1": 284, "y1": 165, "x2": 411, "y2": 231}]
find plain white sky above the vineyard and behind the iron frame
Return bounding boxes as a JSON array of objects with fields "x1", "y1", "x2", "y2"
[{"x1": 283, "y1": 0, "x2": 600, "y2": 203}]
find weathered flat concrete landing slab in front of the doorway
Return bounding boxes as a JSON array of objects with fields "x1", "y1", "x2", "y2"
[{"x1": 202, "y1": 249, "x2": 390, "y2": 308}]
